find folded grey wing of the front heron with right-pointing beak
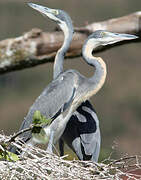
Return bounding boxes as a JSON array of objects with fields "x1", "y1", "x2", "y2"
[{"x1": 20, "y1": 72, "x2": 75, "y2": 141}]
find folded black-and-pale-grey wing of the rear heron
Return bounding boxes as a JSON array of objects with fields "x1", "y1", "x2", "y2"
[{"x1": 78, "y1": 101, "x2": 101, "y2": 161}]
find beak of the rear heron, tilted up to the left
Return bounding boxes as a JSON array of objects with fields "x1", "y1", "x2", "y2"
[{"x1": 27, "y1": 3, "x2": 56, "y2": 16}]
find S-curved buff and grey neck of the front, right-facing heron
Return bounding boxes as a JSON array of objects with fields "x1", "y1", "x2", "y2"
[{"x1": 82, "y1": 40, "x2": 107, "y2": 94}]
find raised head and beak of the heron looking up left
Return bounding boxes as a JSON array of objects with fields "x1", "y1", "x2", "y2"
[{"x1": 28, "y1": 3, "x2": 73, "y2": 29}]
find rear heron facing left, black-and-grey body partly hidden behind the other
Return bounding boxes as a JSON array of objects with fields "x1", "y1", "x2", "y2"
[{"x1": 27, "y1": 4, "x2": 101, "y2": 161}]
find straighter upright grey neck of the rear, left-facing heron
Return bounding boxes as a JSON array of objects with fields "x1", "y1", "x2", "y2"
[{"x1": 53, "y1": 25, "x2": 73, "y2": 79}]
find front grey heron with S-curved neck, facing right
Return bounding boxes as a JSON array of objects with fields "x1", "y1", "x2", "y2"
[{"x1": 9, "y1": 4, "x2": 136, "y2": 159}]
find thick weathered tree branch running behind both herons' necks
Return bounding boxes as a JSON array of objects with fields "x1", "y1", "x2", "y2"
[{"x1": 0, "y1": 11, "x2": 141, "y2": 74}]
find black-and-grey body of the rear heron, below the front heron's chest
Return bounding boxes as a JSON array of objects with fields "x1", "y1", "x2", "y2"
[{"x1": 59, "y1": 101, "x2": 101, "y2": 162}]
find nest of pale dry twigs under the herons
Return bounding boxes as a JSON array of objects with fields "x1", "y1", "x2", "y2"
[{"x1": 0, "y1": 134, "x2": 141, "y2": 180}]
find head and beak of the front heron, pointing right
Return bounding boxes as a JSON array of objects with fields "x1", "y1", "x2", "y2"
[{"x1": 88, "y1": 30, "x2": 138, "y2": 46}]
